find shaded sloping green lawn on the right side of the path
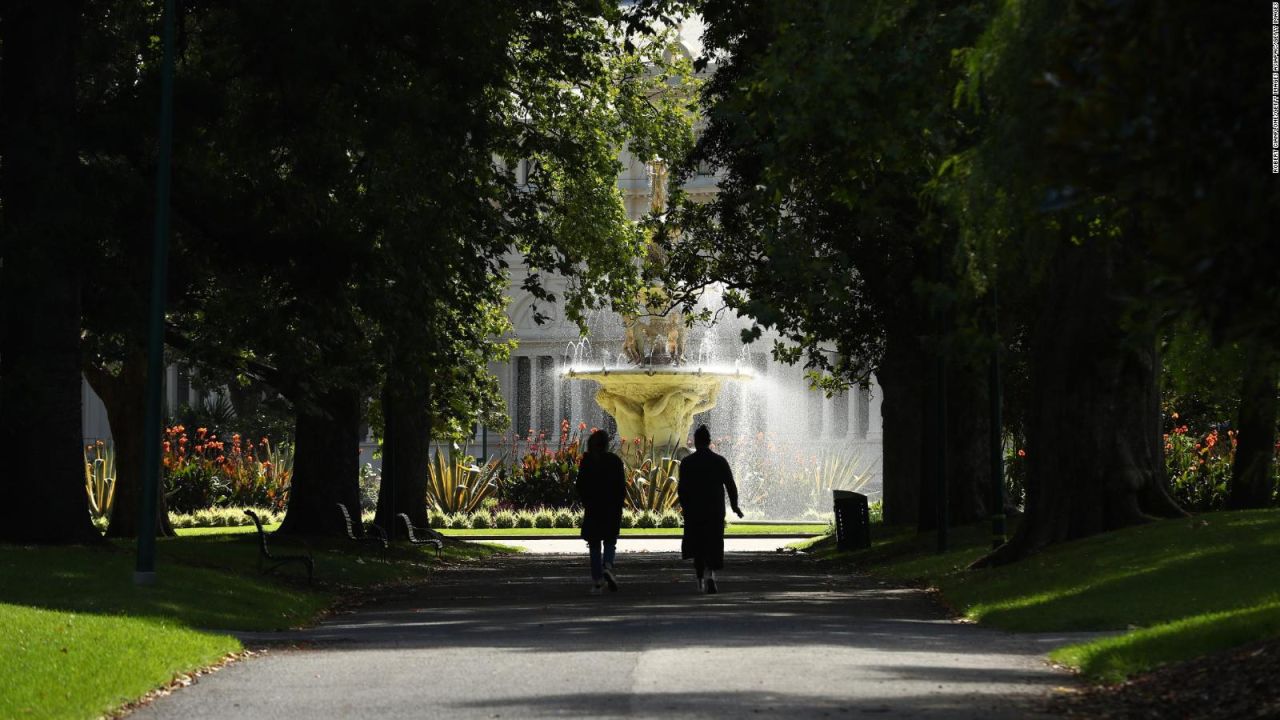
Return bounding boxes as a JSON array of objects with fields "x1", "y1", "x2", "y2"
[{"x1": 812, "y1": 510, "x2": 1280, "y2": 680}]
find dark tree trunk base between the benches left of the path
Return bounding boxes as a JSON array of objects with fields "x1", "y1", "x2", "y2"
[{"x1": 278, "y1": 389, "x2": 362, "y2": 536}]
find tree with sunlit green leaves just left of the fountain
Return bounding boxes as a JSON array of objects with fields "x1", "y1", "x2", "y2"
[{"x1": 375, "y1": 1, "x2": 691, "y2": 532}]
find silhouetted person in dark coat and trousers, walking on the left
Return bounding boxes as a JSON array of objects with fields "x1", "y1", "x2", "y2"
[{"x1": 577, "y1": 430, "x2": 627, "y2": 593}]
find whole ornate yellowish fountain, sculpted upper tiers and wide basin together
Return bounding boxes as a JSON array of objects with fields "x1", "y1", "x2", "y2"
[{"x1": 564, "y1": 160, "x2": 751, "y2": 451}]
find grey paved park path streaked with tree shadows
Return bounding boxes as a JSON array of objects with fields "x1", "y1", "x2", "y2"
[{"x1": 131, "y1": 552, "x2": 1073, "y2": 720}]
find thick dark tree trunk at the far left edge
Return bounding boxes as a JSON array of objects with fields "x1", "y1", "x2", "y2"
[{"x1": 0, "y1": 0, "x2": 101, "y2": 542}]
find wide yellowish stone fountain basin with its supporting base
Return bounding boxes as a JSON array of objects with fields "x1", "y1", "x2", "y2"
[{"x1": 564, "y1": 366, "x2": 751, "y2": 448}]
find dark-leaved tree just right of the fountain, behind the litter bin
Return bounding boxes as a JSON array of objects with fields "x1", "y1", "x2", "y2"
[{"x1": 675, "y1": 1, "x2": 989, "y2": 529}]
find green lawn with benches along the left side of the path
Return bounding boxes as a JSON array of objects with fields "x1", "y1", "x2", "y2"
[{"x1": 0, "y1": 528, "x2": 509, "y2": 719}]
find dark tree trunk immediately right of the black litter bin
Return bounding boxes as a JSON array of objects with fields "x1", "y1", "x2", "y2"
[{"x1": 876, "y1": 323, "x2": 927, "y2": 525}]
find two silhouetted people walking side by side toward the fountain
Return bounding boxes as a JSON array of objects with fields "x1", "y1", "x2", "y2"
[{"x1": 577, "y1": 425, "x2": 742, "y2": 593}]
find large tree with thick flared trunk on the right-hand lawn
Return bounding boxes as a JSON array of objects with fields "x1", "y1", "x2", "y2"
[{"x1": 943, "y1": 3, "x2": 1181, "y2": 564}]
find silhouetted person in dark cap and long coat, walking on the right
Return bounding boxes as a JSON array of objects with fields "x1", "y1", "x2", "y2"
[{"x1": 676, "y1": 425, "x2": 742, "y2": 593}]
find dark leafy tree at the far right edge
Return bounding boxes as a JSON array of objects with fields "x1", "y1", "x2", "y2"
[{"x1": 1029, "y1": 0, "x2": 1280, "y2": 507}]
